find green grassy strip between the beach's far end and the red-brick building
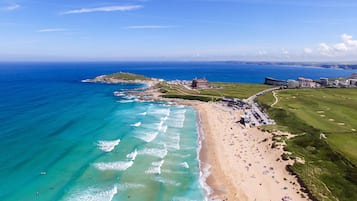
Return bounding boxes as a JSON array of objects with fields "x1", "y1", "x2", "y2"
[{"x1": 157, "y1": 82, "x2": 271, "y2": 102}]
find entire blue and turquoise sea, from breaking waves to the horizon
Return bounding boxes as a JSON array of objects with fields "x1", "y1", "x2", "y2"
[{"x1": 0, "y1": 62, "x2": 356, "y2": 201}]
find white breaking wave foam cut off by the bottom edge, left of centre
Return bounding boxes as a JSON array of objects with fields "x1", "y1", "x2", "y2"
[{"x1": 65, "y1": 186, "x2": 118, "y2": 201}]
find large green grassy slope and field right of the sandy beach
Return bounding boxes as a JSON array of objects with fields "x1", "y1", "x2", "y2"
[{"x1": 257, "y1": 89, "x2": 357, "y2": 201}]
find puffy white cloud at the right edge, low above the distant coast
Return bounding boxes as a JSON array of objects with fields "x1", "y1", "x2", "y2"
[{"x1": 318, "y1": 34, "x2": 357, "y2": 56}]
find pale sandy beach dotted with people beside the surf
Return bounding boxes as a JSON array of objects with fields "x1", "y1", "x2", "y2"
[{"x1": 189, "y1": 102, "x2": 308, "y2": 201}]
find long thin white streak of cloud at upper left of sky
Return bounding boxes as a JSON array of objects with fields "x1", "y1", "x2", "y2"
[{"x1": 62, "y1": 5, "x2": 143, "y2": 15}]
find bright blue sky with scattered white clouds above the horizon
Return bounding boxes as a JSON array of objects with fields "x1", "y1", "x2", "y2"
[{"x1": 0, "y1": 0, "x2": 357, "y2": 62}]
